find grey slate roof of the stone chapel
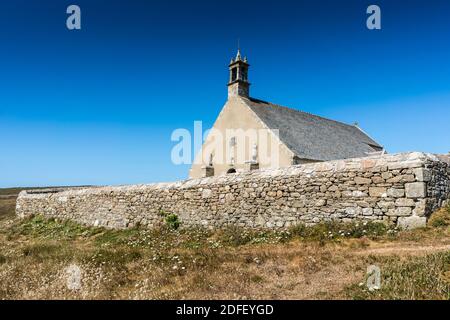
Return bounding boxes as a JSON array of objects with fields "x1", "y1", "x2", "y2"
[{"x1": 243, "y1": 98, "x2": 383, "y2": 161}]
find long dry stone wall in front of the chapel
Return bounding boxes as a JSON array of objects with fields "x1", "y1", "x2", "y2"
[{"x1": 16, "y1": 152, "x2": 450, "y2": 229}]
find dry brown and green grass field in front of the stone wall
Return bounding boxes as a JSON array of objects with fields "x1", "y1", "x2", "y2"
[{"x1": 0, "y1": 192, "x2": 450, "y2": 299}]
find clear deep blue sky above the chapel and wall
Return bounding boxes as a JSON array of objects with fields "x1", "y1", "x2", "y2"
[{"x1": 0, "y1": 0, "x2": 450, "y2": 187}]
